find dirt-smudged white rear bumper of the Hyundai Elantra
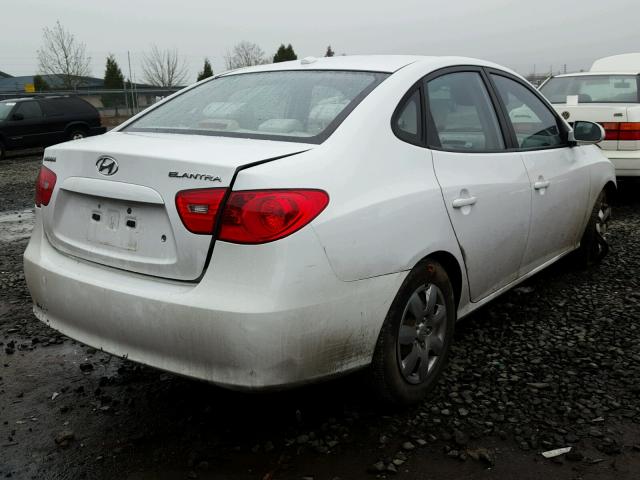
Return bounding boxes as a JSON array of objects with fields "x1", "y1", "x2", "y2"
[{"x1": 24, "y1": 213, "x2": 405, "y2": 389}]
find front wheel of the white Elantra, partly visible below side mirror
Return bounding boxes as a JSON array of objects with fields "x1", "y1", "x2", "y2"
[{"x1": 576, "y1": 190, "x2": 611, "y2": 267}]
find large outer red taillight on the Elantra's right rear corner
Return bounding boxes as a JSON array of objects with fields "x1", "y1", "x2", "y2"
[{"x1": 219, "y1": 190, "x2": 329, "y2": 243}]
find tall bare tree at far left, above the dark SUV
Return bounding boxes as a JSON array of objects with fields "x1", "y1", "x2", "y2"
[{"x1": 38, "y1": 20, "x2": 91, "y2": 89}]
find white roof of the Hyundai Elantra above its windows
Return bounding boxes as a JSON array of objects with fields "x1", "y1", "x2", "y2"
[{"x1": 220, "y1": 55, "x2": 510, "y2": 76}]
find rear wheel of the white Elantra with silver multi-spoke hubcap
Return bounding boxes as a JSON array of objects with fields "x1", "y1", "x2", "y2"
[{"x1": 371, "y1": 259, "x2": 456, "y2": 406}]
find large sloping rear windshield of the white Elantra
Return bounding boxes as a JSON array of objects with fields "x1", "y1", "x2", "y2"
[{"x1": 125, "y1": 70, "x2": 387, "y2": 143}]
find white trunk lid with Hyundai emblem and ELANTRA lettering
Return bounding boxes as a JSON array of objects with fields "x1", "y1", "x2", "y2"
[{"x1": 43, "y1": 132, "x2": 313, "y2": 280}]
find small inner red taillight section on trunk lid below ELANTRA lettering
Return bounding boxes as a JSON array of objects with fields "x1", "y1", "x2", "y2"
[{"x1": 176, "y1": 188, "x2": 227, "y2": 235}]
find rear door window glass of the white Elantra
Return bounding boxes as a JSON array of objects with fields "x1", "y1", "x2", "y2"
[{"x1": 426, "y1": 72, "x2": 505, "y2": 152}]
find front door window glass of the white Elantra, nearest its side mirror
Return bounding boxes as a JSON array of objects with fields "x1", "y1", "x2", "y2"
[{"x1": 491, "y1": 74, "x2": 565, "y2": 148}]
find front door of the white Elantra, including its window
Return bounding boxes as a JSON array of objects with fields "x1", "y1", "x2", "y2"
[{"x1": 490, "y1": 71, "x2": 590, "y2": 274}]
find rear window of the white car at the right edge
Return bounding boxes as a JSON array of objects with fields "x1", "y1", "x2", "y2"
[{"x1": 540, "y1": 75, "x2": 638, "y2": 103}]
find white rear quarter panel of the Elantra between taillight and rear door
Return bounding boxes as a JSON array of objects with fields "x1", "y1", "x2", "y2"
[{"x1": 234, "y1": 65, "x2": 466, "y2": 292}]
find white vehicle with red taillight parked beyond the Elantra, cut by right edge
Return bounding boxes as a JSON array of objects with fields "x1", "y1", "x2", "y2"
[{"x1": 540, "y1": 53, "x2": 640, "y2": 177}]
